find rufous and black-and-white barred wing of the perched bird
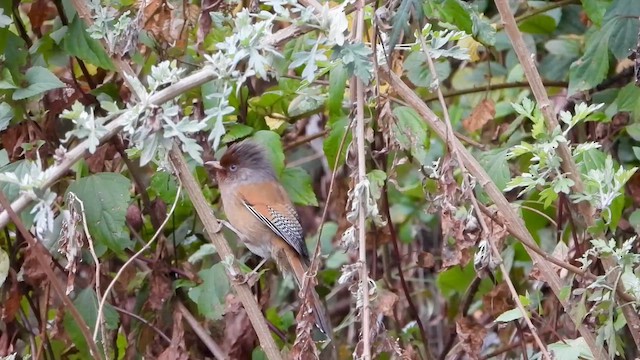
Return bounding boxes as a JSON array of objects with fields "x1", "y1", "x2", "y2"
[{"x1": 238, "y1": 182, "x2": 309, "y2": 261}]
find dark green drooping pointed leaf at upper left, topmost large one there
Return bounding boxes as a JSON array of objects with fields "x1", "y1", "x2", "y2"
[{"x1": 62, "y1": 16, "x2": 115, "y2": 70}]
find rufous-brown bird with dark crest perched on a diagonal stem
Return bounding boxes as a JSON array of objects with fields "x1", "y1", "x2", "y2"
[{"x1": 205, "y1": 140, "x2": 331, "y2": 340}]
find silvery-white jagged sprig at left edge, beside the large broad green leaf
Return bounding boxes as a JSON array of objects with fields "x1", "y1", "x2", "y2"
[{"x1": 0, "y1": 157, "x2": 57, "y2": 238}]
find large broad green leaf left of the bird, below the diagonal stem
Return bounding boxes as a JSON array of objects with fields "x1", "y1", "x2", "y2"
[{"x1": 67, "y1": 173, "x2": 133, "y2": 256}]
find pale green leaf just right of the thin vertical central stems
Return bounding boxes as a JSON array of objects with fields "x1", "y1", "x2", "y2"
[{"x1": 391, "y1": 106, "x2": 429, "y2": 165}]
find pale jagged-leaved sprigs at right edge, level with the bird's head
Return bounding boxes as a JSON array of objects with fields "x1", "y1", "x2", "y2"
[{"x1": 505, "y1": 98, "x2": 636, "y2": 215}]
